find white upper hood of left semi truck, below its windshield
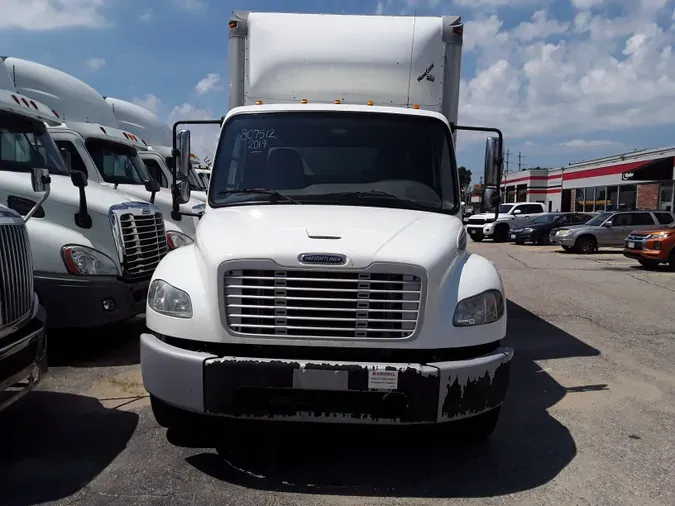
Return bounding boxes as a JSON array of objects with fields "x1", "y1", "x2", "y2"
[{"x1": 2, "y1": 172, "x2": 146, "y2": 217}]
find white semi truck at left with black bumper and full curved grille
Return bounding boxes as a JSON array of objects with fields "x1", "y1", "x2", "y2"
[{"x1": 0, "y1": 60, "x2": 177, "y2": 328}]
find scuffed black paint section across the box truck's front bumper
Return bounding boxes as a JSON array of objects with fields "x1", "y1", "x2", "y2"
[{"x1": 203, "y1": 348, "x2": 513, "y2": 424}]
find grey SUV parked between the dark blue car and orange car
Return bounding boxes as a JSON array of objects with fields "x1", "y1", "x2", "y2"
[{"x1": 549, "y1": 211, "x2": 675, "y2": 254}]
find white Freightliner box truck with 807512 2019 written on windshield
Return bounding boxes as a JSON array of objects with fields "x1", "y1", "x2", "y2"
[{"x1": 141, "y1": 12, "x2": 514, "y2": 439}]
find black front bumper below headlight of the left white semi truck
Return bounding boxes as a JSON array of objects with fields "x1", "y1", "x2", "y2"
[{"x1": 35, "y1": 272, "x2": 150, "y2": 328}]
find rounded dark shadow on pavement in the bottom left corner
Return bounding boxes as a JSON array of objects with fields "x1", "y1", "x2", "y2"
[{"x1": 0, "y1": 391, "x2": 138, "y2": 506}]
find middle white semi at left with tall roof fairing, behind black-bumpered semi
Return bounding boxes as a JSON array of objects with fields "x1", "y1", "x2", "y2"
[{"x1": 5, "y1": 57, "x2": 202, "y2": 241}]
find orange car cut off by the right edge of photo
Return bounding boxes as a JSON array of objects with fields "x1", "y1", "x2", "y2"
[{"x1": 623, "y1": 213, "x2": 675, "y2": 269}]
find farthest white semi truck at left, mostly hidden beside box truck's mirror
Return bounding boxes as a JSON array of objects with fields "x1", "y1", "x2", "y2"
[{"x1": 104, "y1": 97, "x2": 206, "y2": 202}]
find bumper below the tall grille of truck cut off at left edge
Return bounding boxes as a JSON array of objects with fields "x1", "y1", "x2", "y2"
[{"x1": 0, "y1": 307, "x2": 47, "y2": 411}]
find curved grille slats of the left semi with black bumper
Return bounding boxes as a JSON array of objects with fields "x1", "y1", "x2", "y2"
[{"x1": 119, "y1": 213, "x2": 169, "y2": 279}]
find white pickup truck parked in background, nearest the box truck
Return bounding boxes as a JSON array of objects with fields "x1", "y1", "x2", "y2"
[{"x1": 466, "y1": 202, "x2": 546, "y2": 242}]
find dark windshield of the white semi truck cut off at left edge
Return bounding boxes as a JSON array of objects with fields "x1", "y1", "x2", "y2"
[{"x1": 0, "y1": 112, "x2": 68, "y2": 176}]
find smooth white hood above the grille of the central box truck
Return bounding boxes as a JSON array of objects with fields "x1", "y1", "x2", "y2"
[{"x1": 196, "y1": 205, "x2": 463, "y2": 271}]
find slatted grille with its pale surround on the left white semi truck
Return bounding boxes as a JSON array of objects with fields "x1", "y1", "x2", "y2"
[{"x1": 111, "y1": 202, "x2": 169, "y2": 280}]
